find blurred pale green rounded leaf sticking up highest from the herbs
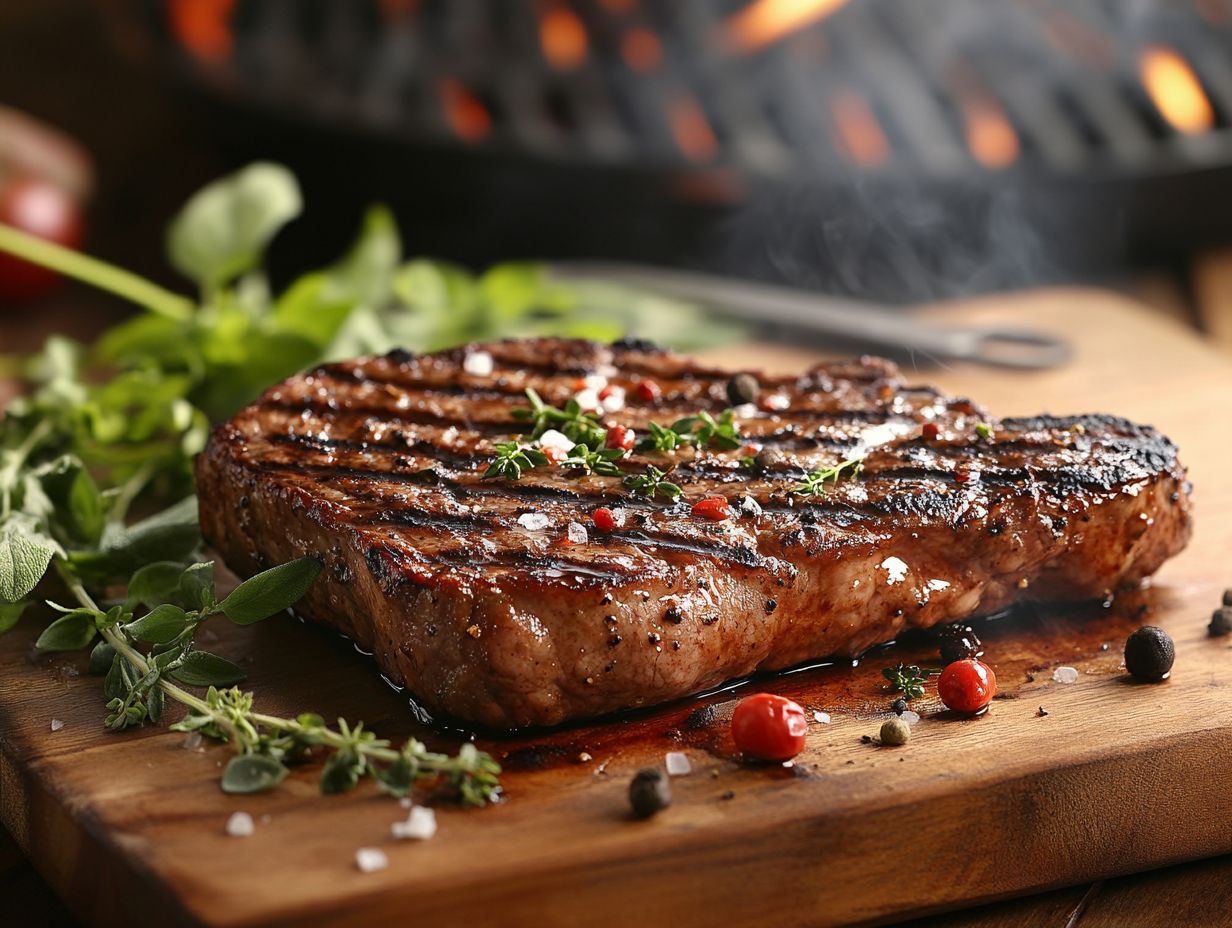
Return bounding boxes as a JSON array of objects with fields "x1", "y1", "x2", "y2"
[{"x1": 166, "y1": 161, "x2": 303, "y2": 291}]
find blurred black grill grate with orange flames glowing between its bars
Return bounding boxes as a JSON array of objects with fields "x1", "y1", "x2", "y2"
[{"x1": 149, "y1": 0, "x2": 1232, "y2": 177}]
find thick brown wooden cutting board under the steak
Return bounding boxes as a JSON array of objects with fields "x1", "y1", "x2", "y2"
[{"x1": 0, "y1": 285, "x2": 1232, "y2": 928}]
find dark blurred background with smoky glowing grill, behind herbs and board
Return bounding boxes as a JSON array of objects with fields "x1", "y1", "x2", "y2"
[{"x1": 7, "y1": 0, "x2": 1232, "y2": 357}]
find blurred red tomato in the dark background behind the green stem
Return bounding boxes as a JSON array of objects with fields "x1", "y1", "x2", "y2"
[{"x1": 0, "y1": 177, "x2": 81, "y2": 301}]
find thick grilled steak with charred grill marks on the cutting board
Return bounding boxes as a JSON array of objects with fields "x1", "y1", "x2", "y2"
[{"x1": 197, "y1": 339, "x2": 1190, "y2": 727}]
